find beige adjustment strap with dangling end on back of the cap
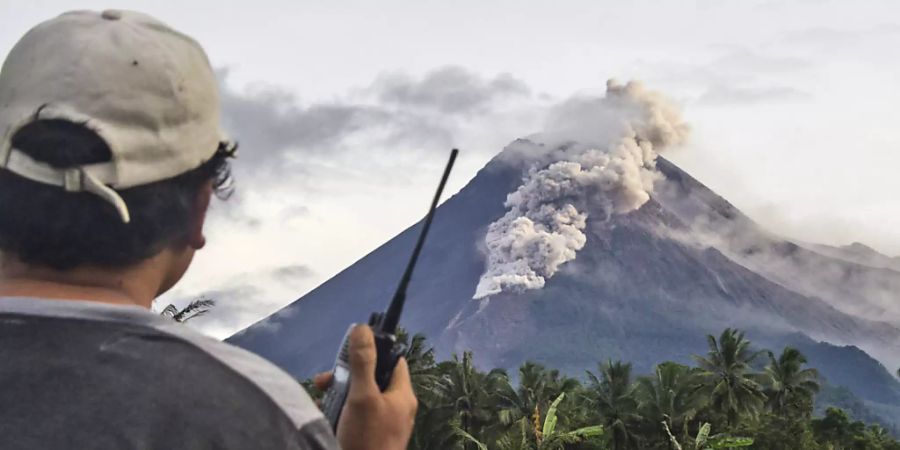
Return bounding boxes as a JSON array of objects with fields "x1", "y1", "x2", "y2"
[{"x1": 0, "y1": 148, "x2": 131, "y2": 223}]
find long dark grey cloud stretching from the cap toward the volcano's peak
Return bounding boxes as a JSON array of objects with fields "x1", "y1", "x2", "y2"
[{"x1": 217, "y1": 66, "x2": 531, "y2": 170}]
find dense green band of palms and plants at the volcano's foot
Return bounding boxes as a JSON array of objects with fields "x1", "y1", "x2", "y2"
[{"x1": 307, "y1": 329, "x2": 900, "y2": 450}]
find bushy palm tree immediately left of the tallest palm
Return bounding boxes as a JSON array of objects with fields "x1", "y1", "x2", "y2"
[{"x1": 636, "y1": 361, "x2": 705, "y2": 442}]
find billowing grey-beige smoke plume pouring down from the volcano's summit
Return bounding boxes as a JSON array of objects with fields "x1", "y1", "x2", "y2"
[{"x1": 473, "y1": 80, "x2": 688, "y2": 299}]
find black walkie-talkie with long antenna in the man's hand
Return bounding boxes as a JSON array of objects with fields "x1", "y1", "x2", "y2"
[{"x1": 322, "y1": 149, "x2": 459, "y2": 432}]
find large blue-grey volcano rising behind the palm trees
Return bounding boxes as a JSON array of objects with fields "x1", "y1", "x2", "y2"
[{"x1": 229, "y1": 140, "x2": 900, "y2": 423}]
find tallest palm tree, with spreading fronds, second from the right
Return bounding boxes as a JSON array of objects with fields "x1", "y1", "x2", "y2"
[{"x1": 694, "y1": 328, "x2": 766, "y2": 429}]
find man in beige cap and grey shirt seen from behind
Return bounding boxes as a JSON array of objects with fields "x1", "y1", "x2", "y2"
[{"x1": 0, "y1": 7, "x2": 416, "y2": 450}]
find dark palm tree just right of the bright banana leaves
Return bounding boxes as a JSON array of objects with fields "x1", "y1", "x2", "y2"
[{"x1": 587, "y1": 361, "x2": 640, "y2": 450}]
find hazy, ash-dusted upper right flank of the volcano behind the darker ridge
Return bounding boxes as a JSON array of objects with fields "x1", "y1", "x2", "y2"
[{"x1": 656, "y1": 159, "x2": 900, "y2": 336}]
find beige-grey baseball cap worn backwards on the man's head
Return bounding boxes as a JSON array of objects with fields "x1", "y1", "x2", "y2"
[{"x1": 0, "y1": 10, "x2": 233, "y2": 222}]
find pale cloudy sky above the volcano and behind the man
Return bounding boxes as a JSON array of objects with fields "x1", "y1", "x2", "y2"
[{"x1": 0, "y1": 0, "x2": 900, "y2": 337}]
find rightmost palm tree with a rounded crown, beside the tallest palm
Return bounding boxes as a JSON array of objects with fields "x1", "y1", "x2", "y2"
[{"x1": 765, "y1": 347, "x2": 820, "y2": 415}]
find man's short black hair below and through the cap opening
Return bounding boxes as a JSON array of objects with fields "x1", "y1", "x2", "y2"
[{"x1": 0, "y1": 119, "x2": 234, "y2": 270}]
